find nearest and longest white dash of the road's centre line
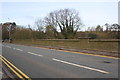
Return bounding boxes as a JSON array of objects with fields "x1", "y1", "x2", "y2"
[{"x1": 52, "y1": 58, "x2": 109, "y2": 74}]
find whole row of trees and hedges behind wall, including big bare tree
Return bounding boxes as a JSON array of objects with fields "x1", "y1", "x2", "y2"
[{"x1": 0, "y1": 9, "x2": 120, "y2": 39}]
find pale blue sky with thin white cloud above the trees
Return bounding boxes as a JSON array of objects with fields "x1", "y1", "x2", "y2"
[{"x1": 0, "y1": 1, "x2": 118, "y2": 30}]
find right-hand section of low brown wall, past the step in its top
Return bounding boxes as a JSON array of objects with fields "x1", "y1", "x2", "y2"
[{"x1": 89, "y1": 39, "x2": 120, "y2": 52}]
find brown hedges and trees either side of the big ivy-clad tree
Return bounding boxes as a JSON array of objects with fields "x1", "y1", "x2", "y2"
[{"x1": 2, "y1": 23, "x2": 120, "y2": 39}]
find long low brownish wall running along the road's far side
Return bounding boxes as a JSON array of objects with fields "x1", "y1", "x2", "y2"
[{"x1": 13, "y1": 39, "x2": 119, "y2": 53}]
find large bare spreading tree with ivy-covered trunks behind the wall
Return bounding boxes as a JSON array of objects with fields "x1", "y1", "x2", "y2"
[{"x1": 45, "y1": 9, "x2": 82, "y2": 39}]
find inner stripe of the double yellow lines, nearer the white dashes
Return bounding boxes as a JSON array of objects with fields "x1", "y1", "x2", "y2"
[{"x1": 0, "y1": 55, "x2": 32, "y2": 80}]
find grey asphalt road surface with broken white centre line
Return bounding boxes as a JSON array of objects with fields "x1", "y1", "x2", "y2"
[{"x1": 2, "y1": 43, "x2": 118, "y2": 78}]
